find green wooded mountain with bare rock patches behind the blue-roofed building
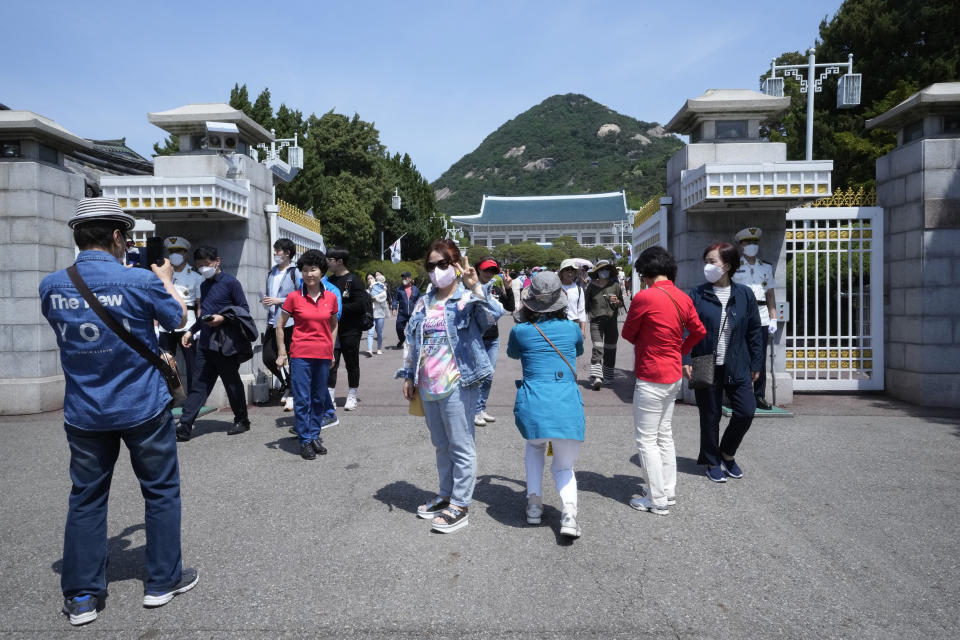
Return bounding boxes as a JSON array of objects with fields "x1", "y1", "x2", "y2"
[{"x1": 431, "y1": 93, "x2": 683, "y2": 215}]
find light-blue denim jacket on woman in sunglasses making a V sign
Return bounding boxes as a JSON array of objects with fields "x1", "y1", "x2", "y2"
[{"x1": 394, "y1": 284, "x2": 504, "y2": 387}]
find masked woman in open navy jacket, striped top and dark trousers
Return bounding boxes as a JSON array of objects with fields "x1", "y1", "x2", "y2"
[{"x1": 683, "y1": 242, "x2": 763, "y2": 482}]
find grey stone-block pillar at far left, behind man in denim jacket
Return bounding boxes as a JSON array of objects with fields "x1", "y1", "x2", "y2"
[{"x1": 0, "y1": 110, "x2": 93, "y2": 415}]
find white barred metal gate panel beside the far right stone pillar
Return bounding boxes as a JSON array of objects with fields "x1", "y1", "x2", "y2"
[{"x1": 783, "y1": 207, "x2": 883, "y2": 391}]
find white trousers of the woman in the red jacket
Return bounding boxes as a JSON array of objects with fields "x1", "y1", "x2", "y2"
[{"x1": 633, "y1": 380, "x2": 680, "y2": 507}]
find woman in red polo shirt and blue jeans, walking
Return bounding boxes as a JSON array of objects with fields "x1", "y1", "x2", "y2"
[{"x1": 277, "y1": 249, "x2": 337, "y2": 460}]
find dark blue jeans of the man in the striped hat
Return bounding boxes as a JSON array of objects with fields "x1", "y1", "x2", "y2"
[{"x1": 60, "y1": 409, "x2": 182, "y2": 598}]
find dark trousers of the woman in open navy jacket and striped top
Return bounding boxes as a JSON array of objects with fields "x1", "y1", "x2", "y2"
[{"x1": 694, "y1": 365, "x2": 757, "y2": 467}]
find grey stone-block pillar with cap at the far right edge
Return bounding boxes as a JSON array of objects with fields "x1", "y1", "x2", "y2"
[{"x1": 867, "y1": 82, "x2": 960, "y2": 407}]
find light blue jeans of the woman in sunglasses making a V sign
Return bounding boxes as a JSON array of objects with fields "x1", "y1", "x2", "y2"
[{"x1": 423, "y1": 386, "x2": 477, "y2": 507}]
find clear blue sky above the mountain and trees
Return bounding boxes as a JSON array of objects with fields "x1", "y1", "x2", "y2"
[{"x1": 0, "y1": 0, "x2": 844, "y2": 181}]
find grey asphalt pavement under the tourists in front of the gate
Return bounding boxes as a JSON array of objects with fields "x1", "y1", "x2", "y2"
[{"x1": 0, "y1": 319, "x2": 960, "y2": 638}]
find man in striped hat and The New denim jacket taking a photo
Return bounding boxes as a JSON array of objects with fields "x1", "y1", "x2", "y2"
[{"x1": 40, "y1": 198, "x2": 198, "y2": 625}]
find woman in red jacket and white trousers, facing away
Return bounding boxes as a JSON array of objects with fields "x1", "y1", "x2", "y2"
[{"x1": 622, "y1": 247, "x2": 707, "y2": 515}]
